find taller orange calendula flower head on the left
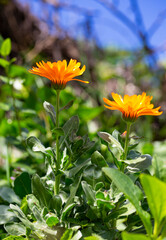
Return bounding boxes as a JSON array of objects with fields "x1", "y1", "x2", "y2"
[{"x1": 29, "y1": 59, "x2": 89, "y2": 90}]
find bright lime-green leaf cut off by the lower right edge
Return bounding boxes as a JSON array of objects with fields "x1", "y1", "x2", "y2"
[{"x1": 140, "y1": 174, "x2": 166, "y2": 225}]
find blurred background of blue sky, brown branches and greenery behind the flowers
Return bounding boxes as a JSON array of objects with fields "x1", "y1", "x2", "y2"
[{"x1": 0, "y1": 0, "x2": 166, "y2": 178}]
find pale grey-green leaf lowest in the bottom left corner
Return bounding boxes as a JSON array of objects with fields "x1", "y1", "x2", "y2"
[{"x1": 5, "y1": 223, "x2": 26, "y2": 236}]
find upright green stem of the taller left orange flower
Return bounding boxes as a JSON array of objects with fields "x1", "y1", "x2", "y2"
[{"x1": 54, "y1": 90, "x2": 61, "y2": 195}]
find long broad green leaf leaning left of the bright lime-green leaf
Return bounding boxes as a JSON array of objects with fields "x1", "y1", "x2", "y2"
[{"x1": 103, "y1": 168, "x2": 152, "y2": 235}]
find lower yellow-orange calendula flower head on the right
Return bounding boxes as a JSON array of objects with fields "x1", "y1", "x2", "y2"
[{"x1": 103, "y1": 92, "x2": 163, "y2": 122}]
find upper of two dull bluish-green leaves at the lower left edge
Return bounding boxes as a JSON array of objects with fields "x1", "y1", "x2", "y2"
[{"x1": 0, "y1": 187, "x2": 21, "y2": 204}]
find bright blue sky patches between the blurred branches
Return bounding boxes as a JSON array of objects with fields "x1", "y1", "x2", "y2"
[{"x1": 20, "y1": 0, "x2": 166, "y2": 59}]
